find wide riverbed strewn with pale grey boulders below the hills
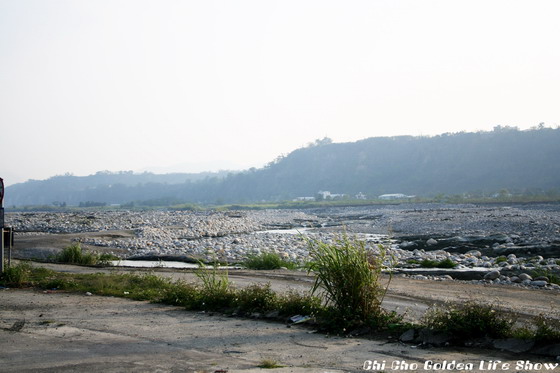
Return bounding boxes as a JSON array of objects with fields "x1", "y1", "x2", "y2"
[{"x1": 6, "y1": 204, "x2": 560, "y2": 289}]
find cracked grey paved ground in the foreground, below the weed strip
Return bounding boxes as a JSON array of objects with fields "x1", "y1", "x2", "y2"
[{"x1": 0, "y1": 290, "x2": 537, "y2": 372}]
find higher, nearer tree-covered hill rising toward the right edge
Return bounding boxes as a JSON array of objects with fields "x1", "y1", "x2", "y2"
[{"x1": 224, "y1": 127, "x2": 560, "y2": 203}]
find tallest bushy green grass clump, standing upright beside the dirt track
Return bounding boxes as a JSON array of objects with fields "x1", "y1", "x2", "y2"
[{"x1": 308, "y1": 235, "x2": 394, "y2": 330}]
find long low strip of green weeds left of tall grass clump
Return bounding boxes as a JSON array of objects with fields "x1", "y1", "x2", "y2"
[{"x1": 0, "y1": 262, "x2": 321, "y2": 316}]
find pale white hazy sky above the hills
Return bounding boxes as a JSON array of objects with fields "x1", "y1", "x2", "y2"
[{"x1": 0, "y1": 0, "x2": 560, "y2": 185}]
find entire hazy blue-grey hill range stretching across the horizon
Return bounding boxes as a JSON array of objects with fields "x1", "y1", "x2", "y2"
[{"x1": 6, "y1": 127, "x2": 560, "y2": 206}]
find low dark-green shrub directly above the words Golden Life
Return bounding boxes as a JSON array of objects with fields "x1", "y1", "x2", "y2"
[{"x1": 423, "y1": 301, "x2": 514, "y2": 340}]
